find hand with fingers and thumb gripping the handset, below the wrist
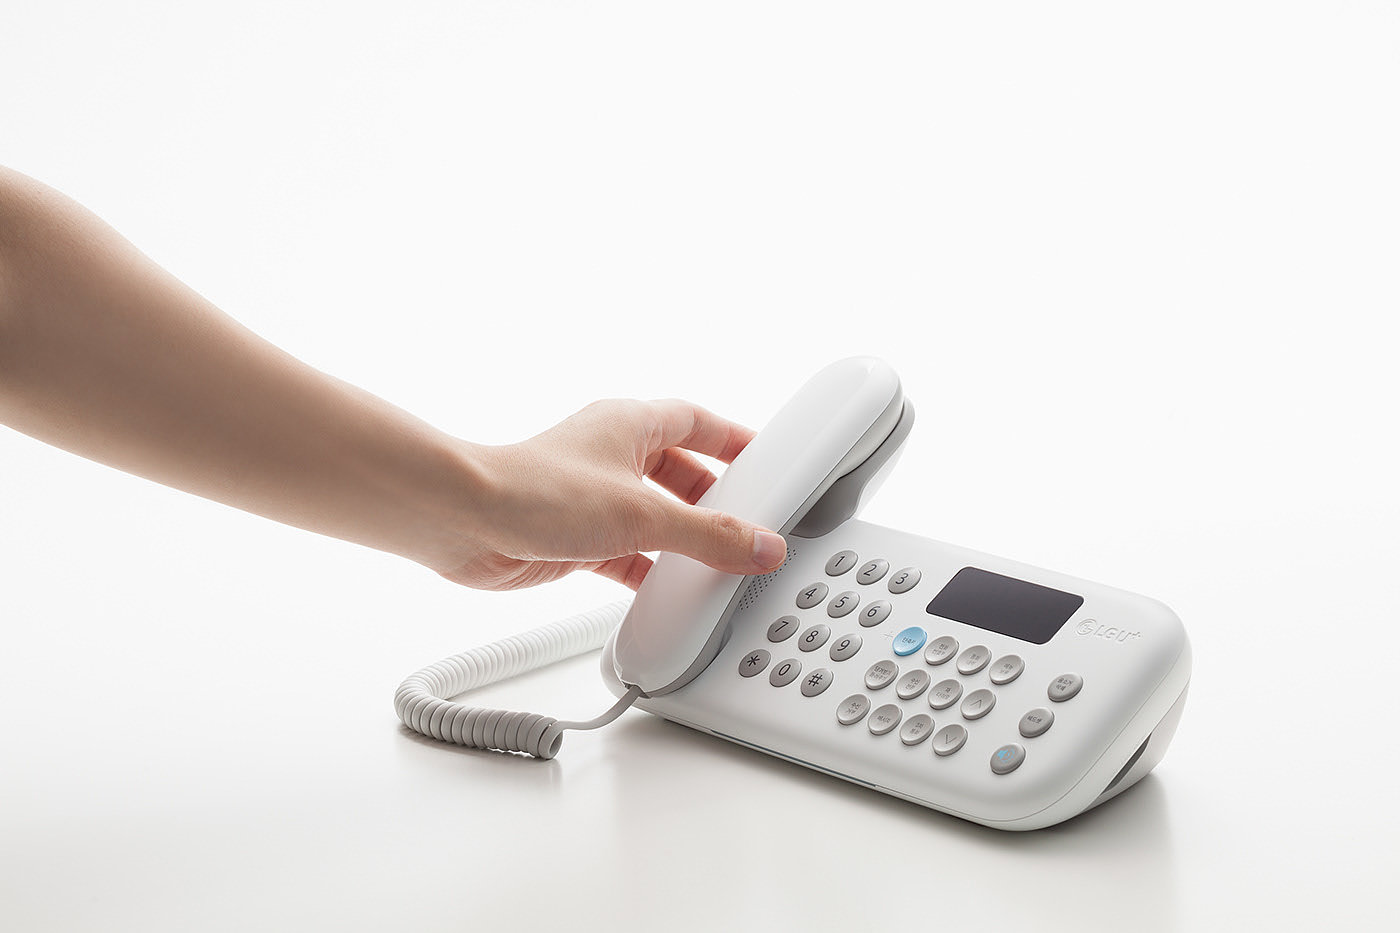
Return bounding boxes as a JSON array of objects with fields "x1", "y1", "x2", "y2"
[{"x1": 430, "y1": 399, "x2": 787, "y2": 590}]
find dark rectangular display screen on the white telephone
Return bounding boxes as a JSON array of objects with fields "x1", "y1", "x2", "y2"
[{"x1": 928, "y1": 567, "x2": 1084, "y2": 644}]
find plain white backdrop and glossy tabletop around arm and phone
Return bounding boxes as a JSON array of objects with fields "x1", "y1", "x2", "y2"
[{"x1": 0, "y1": 0, "x2": 1400, "y2": 933}]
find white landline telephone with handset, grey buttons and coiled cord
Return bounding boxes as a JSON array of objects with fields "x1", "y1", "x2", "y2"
[{"x1": 395, "y1": 357, "x2": 1191, "y2": 829}]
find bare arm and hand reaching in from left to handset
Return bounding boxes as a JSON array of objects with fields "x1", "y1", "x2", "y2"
[{"x1": 0, "y1": 168, "x2": 783, "y2": 588}]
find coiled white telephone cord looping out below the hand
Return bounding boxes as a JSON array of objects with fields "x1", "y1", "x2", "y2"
[{"x1": 393, "y1": 600, "x2": 641, "y2": 758}]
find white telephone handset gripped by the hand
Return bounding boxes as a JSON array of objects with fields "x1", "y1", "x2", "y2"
[{"x1": 612, "y1": 357, "x2": 913, "y2": 696}]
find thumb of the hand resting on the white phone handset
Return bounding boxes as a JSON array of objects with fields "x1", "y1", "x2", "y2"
[{"x1": 648, "y1": 496, "x2": 787, "y2": 574}]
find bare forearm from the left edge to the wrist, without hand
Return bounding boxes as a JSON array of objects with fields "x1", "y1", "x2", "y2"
[{"x1": 0, "y1": 170, "x2": 487, "y2": 566}]
